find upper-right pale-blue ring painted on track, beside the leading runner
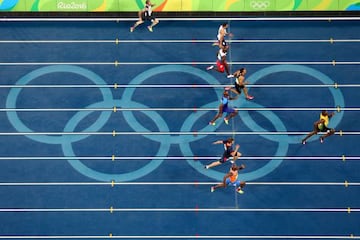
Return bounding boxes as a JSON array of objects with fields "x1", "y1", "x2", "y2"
[{"x1": 245, "y1": 65, "x2": 345, "y2": 144}]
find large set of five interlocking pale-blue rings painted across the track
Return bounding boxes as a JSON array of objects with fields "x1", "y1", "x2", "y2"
[{"x1": 6, "y1": 65, "x2": 344, "y2": 181}]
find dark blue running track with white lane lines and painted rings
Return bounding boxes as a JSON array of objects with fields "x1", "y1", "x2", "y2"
[{"x1": 0, "y1": 19, "x2": 360, "y2": 239}]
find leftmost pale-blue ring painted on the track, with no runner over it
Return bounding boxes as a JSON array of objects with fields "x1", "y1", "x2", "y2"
[{"x1": 6, "y1": 65, "x2": 113, "y2": 144}]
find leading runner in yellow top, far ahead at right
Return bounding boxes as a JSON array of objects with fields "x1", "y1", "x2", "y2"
[{"x1": 301, "y1": 110, "x2": 335, "y2": 144}]
